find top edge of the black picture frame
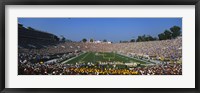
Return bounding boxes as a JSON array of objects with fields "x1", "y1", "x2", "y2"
[{"x1": 1, "y1": 0, "x2": 199, "y2": 5}]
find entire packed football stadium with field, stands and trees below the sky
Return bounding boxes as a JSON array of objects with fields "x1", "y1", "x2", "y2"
[{"x1": 18, "y1": 18, "x2": 182, "y2": 75}]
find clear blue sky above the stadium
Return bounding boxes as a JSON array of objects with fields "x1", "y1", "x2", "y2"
[{"x1": 18, "y1": 18, "x2": 182, "y2": 42}]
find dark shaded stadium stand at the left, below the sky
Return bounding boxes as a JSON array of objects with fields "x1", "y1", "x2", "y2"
[{"x1": 18, "y1": 24, "x2": 58, "y2": 48}]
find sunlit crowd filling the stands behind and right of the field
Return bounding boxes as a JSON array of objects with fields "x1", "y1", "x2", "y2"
[{"x1": 19, "y1": 37, "x2": 182, "y2": 61}]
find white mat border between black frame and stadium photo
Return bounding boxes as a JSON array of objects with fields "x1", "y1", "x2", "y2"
[{"x1": 5, "y1": 5, "x2": 195, "y2": 88}]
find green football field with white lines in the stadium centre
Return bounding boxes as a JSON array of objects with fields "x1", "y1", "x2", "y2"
[{"x1": 62, "y1": 52, "x2": 148, "y2": 65}]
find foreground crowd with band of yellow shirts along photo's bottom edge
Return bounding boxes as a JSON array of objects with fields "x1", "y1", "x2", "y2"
[{"x1": 18, "y1": 63, "x2": 182, "y2": 75}]
